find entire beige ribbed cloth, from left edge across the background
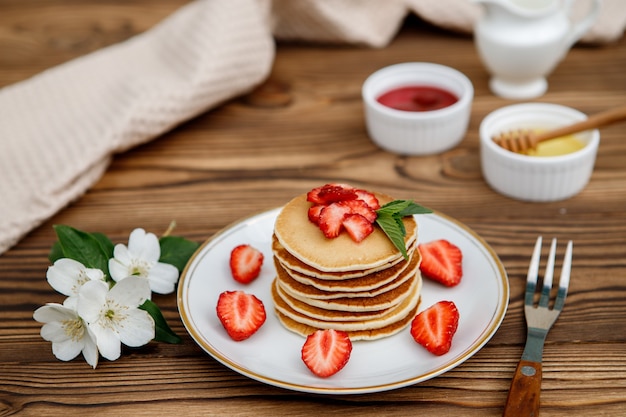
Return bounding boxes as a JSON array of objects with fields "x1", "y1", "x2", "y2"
[{"x1": 0, "y1": 0, "x2": 626, "y2": 254}]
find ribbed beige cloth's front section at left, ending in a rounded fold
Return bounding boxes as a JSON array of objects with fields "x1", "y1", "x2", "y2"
[{"x1": 0, "y1": 0, "x2": 274, "y2": 253}]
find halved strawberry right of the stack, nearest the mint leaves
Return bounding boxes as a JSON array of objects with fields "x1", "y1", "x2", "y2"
[{"x1": 418, "y1": 239, "x2": 463, "y2": 287}]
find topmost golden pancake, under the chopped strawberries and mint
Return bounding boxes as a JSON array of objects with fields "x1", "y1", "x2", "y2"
[{"x1": 274, "y1": 194, "x2": 417, "y2": 272}]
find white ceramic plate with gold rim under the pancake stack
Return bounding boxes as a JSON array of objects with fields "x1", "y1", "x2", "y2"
[{"x1": 178, "y1": 209, "x2": 509, "y2": 394}]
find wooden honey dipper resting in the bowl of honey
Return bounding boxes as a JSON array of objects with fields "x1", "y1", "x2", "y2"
[{"x1": 493, "y1": 106, "x2": 626, "y2": 153}]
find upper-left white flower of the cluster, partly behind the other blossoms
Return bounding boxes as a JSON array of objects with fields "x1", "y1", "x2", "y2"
[{"x1": 46, "y1": 258, "x2": 105, "y2": 307}]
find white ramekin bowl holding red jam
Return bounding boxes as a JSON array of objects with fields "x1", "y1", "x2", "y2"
[{"x1": 362, "y1": 62, "x2": 474, "y2": 155}]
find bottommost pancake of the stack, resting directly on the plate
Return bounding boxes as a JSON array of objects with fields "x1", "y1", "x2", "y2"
[{"x1": 272, "y1": 275, "x2": 422, "y2": 340}]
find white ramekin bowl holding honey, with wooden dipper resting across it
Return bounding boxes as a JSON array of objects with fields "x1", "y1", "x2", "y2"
[{"x1": 479, "y1": 103, "x2": 600, "y2": 202}]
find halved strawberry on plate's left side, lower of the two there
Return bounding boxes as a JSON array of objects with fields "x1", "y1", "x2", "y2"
[{"x1": 216, "y1": 291, "x2": 266, "y2": 342}]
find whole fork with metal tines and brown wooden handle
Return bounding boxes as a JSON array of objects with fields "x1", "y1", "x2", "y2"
[{"x1": 503, "y1": 236, "x2": 573, "y2": 417}]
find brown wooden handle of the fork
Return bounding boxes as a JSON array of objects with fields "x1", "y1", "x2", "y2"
[{"x1": 502, "y1": 359, "x2": 541, "y2": 417}]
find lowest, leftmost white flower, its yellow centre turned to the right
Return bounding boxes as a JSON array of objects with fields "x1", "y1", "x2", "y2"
[{"x1": 33, "y1": 303, "x2": 98, "y2": 368}]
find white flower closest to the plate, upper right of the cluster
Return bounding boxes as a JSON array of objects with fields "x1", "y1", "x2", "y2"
[{"x1": 109, "y1": 228, "x2": 178, "y2": 294}]
